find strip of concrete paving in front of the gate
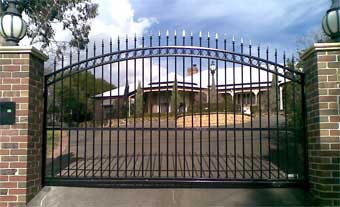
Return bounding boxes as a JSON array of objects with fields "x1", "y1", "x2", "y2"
[{"x1": 28, "y1": 187, "x2": 315, "y2": 207}]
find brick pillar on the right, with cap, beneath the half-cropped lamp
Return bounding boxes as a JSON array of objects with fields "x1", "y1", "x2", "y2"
[{"x1": 302, "y1": 43, "x2": 340, "y2": 206}]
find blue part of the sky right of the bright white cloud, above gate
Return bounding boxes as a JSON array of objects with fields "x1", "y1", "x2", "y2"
[{"x1": 130, "y1": 0, "x2": 330, "y2": 52}]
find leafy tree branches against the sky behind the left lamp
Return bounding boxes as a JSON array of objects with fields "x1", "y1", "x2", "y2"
[{"x1": 0, "y1": 0, "x2": 98, "y2": 49}]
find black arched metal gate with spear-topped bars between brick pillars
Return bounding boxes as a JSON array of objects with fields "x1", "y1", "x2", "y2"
[{"x1": 43, "y1": 32, "x2": 307, "y2": 187}]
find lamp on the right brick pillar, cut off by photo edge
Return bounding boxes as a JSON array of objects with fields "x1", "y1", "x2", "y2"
[{"x1": 322, "y1": 0, "x2": 340, "y2": 42}]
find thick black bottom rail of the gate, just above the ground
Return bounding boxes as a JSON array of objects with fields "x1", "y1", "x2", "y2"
[{"x1": 45, "y1": 177, "x2": 306, "y2": 188}]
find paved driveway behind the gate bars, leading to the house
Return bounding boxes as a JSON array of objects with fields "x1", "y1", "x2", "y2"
[{"x1": 47, "y1": 117, "x2": 298, "y2": 179}]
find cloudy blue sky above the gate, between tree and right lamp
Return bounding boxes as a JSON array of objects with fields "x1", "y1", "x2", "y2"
[{"x1": 83, "y1": 0, "x2": 330, "y2": 53}]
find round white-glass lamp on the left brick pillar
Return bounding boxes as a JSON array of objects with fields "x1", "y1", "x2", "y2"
[{"x1": 0, "y1": 0, "x2": 27, "y2": 46}]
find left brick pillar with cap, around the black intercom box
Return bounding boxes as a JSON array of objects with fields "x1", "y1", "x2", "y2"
[{"x1": 0, "y1": 47, "x2": 47, "y2": 207}]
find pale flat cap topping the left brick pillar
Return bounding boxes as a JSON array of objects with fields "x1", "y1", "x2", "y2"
[{"x1": 0, "y1": 46, "x2": 49, "y2": 61}]
